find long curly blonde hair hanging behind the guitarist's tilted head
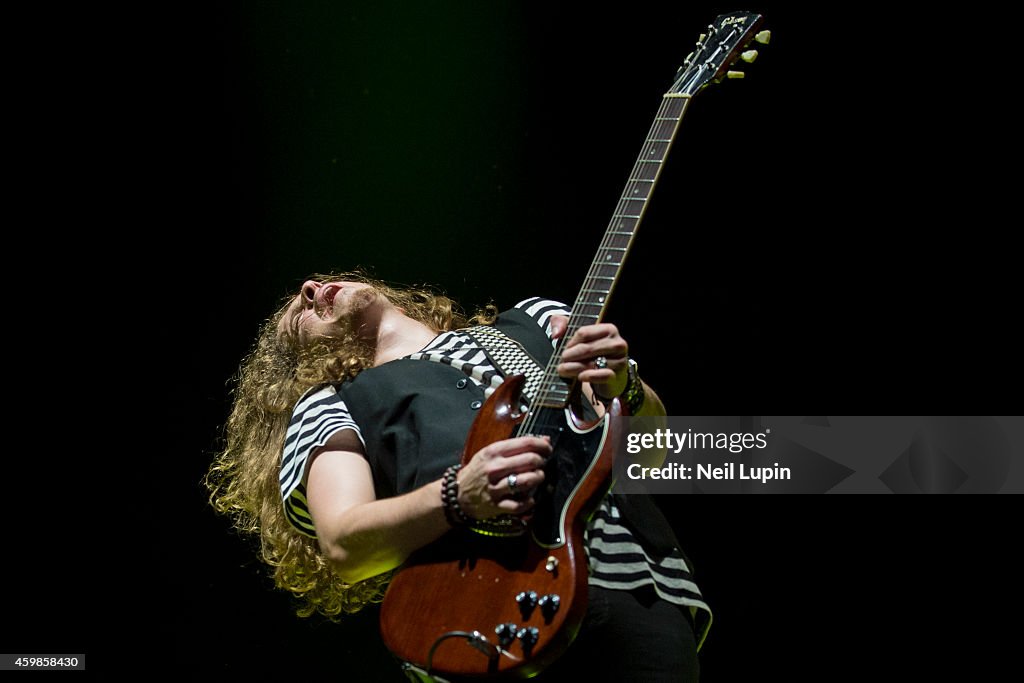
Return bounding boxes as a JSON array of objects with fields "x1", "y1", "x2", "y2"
[{"x1": 204, "y1": 271, "x2": 497, "y2": 618}]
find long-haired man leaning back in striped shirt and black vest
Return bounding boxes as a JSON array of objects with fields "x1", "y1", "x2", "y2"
[{"x1": 207, "y1": 273, "x2": 711, "y2": 682}]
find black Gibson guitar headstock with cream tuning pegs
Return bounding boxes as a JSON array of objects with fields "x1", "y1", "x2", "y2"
[{"x1": 669, "y1": 12, "x2": 771, "y2": 95}]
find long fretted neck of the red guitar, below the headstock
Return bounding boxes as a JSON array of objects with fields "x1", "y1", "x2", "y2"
[{"x1": 537, "y1": 93, "x2": 690, "y2": 408}]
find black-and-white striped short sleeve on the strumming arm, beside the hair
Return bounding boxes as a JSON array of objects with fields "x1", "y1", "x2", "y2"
[{"x1": 280, "y1": 385, "x2": 366, "y2": 537}]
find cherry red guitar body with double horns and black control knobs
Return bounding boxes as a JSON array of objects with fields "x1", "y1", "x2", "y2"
[{"x1": 381, "y1": 376, "x2": 620, "y2": 679}]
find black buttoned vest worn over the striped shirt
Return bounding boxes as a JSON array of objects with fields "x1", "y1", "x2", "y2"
[{"x1": 339, "y1": 308, "x2": 679, "y2": 556}]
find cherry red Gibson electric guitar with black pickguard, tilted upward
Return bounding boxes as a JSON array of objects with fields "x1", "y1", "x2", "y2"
[{"x1": 380, "y1": 12, "x2": 769, "y2": 680}]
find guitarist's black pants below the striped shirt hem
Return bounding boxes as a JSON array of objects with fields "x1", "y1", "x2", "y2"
[{"x1": 531, "y1": 586, "x2": 700, "y2": 683}]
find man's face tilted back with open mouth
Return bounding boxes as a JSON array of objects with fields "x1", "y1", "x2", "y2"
[{"x1": 278, "y1": 281, "x2": 386, "y2": 347}]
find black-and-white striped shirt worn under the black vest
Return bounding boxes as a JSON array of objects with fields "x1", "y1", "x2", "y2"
[{"x1": 281, "y1": 297, "x2": 711, "y2": 645}]
